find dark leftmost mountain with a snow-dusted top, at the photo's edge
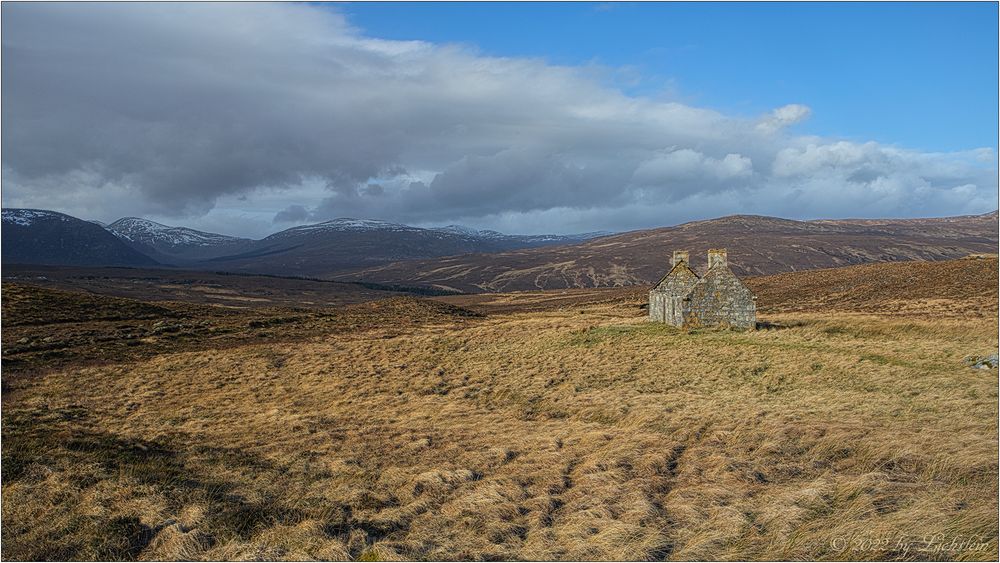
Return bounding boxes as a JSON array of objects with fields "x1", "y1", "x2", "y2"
[{"x1": 2, "y1": 209, "x2": 156, "y2": 266}]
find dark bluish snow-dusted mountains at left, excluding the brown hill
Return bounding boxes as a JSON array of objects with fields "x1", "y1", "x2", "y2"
[{"x1": 3, "y1": 209, "x2": 610, "y2": 276}]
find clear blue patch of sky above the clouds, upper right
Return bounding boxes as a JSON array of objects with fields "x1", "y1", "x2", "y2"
[{"x1": 340, "y1": 2, "x2": 998, "y2": 151}]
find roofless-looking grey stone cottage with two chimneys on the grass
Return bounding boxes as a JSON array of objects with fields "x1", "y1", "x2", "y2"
[{"x1": 649, "y1": 248, "x2": 757, "y2": 329}]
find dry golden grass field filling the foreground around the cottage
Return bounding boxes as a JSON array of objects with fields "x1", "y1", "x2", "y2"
[{"x1": 2, "y1": 286, "x2": 998, "y2": 560}]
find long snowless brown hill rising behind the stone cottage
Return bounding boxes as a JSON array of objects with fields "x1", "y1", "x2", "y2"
[{"x1": 333, "y1": 211, "x2": 1000, "y2": 292}]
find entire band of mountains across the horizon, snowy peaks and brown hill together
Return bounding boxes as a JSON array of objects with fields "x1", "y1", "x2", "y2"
[{"x1": 2, "y1": 209, "x2": 998, "y2": 292}]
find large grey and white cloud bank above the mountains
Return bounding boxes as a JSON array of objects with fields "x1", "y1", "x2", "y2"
[{"x1": 2, "y1": 3, "x2": 997, "y2": 235}]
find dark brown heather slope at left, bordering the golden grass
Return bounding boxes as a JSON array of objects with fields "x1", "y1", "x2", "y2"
[{"x1": 3, "y1": 282, "x2": 479, "y2": 376}]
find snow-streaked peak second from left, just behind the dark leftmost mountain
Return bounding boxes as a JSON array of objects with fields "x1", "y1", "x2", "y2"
[{"x1": 107, "y1": 217, "x2": 251, "y2": 260}]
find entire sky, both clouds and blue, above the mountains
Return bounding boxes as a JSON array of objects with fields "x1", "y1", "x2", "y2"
[{"x1": 0, "y1": 3, "x2": 998, "y2": 237}]
